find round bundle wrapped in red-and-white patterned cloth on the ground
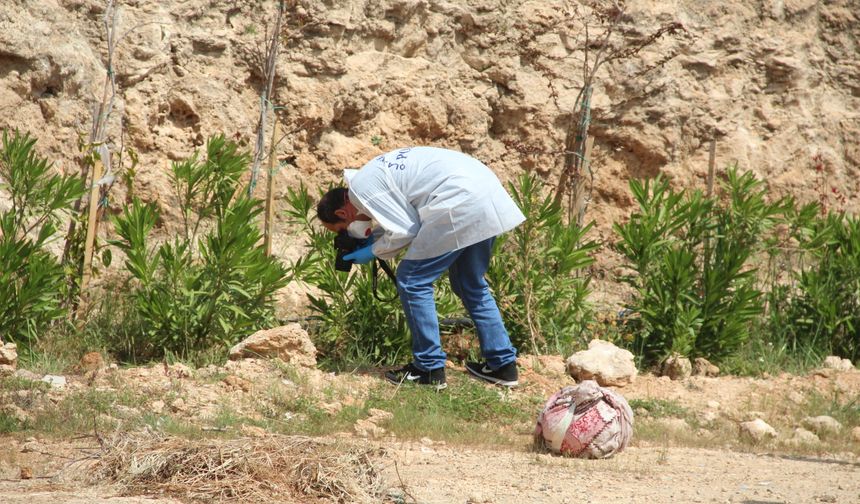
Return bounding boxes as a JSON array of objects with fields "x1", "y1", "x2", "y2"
[{"x1": 534, "y1": 380, "x2": 633, "y2": 458}]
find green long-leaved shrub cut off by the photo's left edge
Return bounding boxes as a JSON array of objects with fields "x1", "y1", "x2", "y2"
[{"x1": 0, "y1": 130, "x2": 85, "y2": 347}]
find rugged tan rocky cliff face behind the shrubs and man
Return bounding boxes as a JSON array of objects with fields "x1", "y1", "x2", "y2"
[{"x1": 0, "y1": 0, "x2": 860, "y2": 239}]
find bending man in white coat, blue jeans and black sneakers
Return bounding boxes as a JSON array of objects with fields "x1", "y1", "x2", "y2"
[{"x1": 317, "y1": 147, "x2": 525, "y2": 389}]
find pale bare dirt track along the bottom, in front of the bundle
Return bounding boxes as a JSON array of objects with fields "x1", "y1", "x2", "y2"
[{"x1": 0, "y1": 442, "x2": 860, "y2": 504}]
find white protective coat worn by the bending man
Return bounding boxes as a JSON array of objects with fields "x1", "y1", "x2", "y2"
[{"x1": 344, "y1": 147, "x2": 525, "y2": 260}]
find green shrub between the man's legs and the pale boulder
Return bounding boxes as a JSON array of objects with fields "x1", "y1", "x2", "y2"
[{"x1": 487, "y1": 174, "x2": 597, "y2": 353}]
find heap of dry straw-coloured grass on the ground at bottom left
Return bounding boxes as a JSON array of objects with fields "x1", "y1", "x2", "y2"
[{"x1": 89, "y1": 435, "x2": 384, "y2": 503}]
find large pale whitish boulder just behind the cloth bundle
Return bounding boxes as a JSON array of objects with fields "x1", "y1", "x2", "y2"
[{"x1": 567, "y1": 339, "x2": 638, "y2": 387}]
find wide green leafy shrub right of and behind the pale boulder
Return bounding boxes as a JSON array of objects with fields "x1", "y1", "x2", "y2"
[{"x1": 614, "y1": 167, "x2": 786, "y2": 365}]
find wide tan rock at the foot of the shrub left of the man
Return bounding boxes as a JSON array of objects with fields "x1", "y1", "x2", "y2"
[{"x1": 230, "y1": 324, "x2": 317, "y2": 368}]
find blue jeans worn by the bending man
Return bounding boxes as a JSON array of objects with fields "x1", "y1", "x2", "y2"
[{"x1": 397, "y1": 238, "x2": 517, "y2": 371}]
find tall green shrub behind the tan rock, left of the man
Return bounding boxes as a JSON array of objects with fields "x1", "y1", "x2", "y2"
[{"x1": 111, "y1": 136, "x2": 287, "y2": 358}]
